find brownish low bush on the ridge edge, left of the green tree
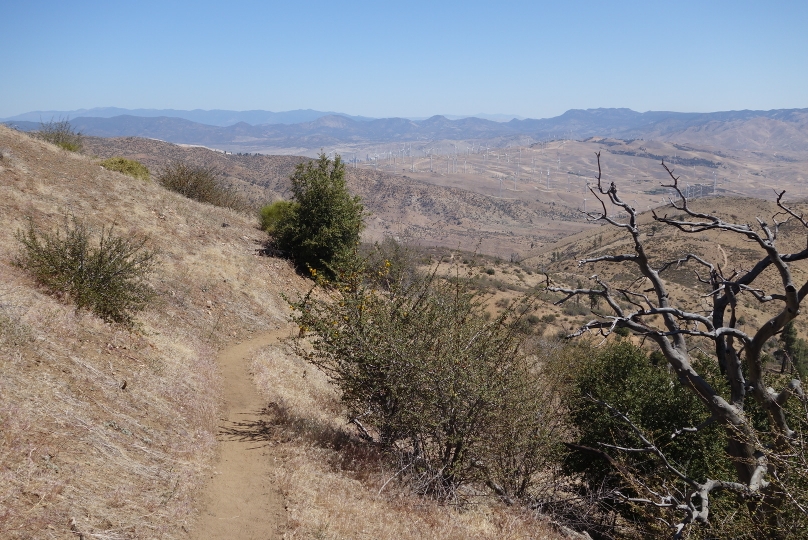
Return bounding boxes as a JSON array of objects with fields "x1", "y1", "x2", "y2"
[{"x1": 157, "y1": 162, "x2": 248, "y2": 211}]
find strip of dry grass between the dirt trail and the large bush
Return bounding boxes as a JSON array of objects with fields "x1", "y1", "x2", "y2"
[{"x1": 252, "y1": 346, "x2": 562, "y2": 540}]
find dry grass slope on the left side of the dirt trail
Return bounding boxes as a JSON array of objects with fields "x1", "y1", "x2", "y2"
[{"x1": 0, "y1": 127, "x2": 305, "y2": 539}]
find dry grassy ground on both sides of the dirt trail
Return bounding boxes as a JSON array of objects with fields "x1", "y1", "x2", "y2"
[{"x1": 0, "y1": 127, "x2": 558, "y2": 539}]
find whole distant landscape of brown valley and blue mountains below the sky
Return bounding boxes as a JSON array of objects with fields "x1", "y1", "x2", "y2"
[{"x1": 15, "y1": 105, "x2": 808, "y2": 259}]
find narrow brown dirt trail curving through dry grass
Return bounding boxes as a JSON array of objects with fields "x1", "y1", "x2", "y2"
[{"x1": 190, "y1": 328, "x2": 290, "y2": 540}]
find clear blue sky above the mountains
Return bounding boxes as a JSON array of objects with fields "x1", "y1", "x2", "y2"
[{"x1": 0, "y1": 0, "x2": 808, "y2": 118}]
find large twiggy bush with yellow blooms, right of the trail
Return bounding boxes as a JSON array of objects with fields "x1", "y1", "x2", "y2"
[{"x1": 294, "y1": 255, "x2": 558, "y2": 498}]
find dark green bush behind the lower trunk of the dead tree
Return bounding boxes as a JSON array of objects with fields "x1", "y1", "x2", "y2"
[{"x1": 565, "y1": 341, "x2": 733, "y2": 537}]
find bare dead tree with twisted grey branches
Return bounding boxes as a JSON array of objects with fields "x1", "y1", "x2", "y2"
[{"x1": 547, "y1": 153, "x2": 808, "y2": 538}]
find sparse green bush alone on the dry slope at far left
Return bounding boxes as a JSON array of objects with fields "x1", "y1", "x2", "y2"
[{"x1": 17, "y1": 218, "x2": 155, "y2": 326}]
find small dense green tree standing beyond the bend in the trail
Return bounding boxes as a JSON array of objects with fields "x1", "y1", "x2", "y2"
[{"x1": 275, "y1": 154, "x2": 364, "y2": 277}]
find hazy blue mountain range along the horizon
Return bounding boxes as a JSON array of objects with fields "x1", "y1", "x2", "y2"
[{"x1": 6, "y1": 109, "x2": 808, "y2": 152}]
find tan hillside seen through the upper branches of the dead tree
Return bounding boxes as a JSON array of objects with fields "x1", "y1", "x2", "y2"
[{"x1": 524, "y1": 197, "x2": 808, "y2": 342}]
